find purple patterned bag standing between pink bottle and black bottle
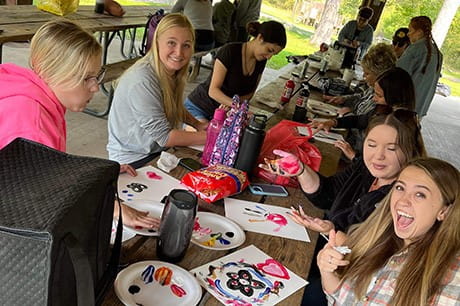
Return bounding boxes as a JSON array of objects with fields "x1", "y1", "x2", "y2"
[{"x1": 209, "y1": 95, "x2": 249, "y2": 167}]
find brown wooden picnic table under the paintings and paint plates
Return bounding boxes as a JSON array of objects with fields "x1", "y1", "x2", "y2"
[{"x1": 103, "y1": 62, "x2": 340, "y2": 306}]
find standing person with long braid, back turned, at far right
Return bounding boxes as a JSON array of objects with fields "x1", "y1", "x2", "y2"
[{"x1": 396, "y1": 16, "x2": 442, "y2": 118}]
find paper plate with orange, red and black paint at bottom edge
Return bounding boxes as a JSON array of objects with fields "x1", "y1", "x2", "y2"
[{"x1": 114, "y1": 260, "x2": 202, "y2": 306}]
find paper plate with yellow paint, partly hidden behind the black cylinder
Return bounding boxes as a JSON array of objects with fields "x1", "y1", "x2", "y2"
[{"x1": 191, "y1": 212, "x2": 246, "y2": 250}]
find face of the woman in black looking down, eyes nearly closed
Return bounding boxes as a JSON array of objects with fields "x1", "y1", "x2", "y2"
[{"x1": 363, "y1": 124, "x2": 404, "y2": 184}]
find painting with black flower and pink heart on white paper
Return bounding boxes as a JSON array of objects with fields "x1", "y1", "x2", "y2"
[{"x1": 190, "y1": 245, "x2": 307, "y2": 306}]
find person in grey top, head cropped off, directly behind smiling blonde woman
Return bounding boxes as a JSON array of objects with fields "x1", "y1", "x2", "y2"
[{"x1": 171, "y1": 0, "x2": 214, "y2": 51}]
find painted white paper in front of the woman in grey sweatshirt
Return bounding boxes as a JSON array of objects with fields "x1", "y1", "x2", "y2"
[{"x1": 118, "y1": 166, "x2": 182, "y2": 202}]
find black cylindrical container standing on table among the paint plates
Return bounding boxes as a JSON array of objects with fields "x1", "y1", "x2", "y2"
[{"x1": 156, "y1": 189, "x2": 198, "y2": 263}]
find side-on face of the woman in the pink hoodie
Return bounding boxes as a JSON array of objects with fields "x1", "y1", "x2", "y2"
[{"x1": 50, "y1": 54, "x2": 101, "y2": 112}]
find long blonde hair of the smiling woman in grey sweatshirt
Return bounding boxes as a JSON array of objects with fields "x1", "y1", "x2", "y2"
[{"x1": 143, "y1": 13, "x2": 195, "y2": 128}]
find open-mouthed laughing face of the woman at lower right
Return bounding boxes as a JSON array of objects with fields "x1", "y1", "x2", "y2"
[{"x1": 390, "y1": 166, "x2": 447, "y2": 245}]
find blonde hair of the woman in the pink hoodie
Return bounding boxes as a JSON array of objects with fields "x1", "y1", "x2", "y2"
[{"x1": 29, "y1": 19, "x2": 102, "y2": 88}]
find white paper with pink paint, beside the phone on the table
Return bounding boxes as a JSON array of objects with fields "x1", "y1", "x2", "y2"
[{"x1": 225, "y1": 198, "x2": 310, "y2": 242}]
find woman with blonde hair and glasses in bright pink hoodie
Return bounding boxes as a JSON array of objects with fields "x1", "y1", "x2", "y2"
[{"x1": 0, "y1": 19, "x2": 158, "y2": 227}]
